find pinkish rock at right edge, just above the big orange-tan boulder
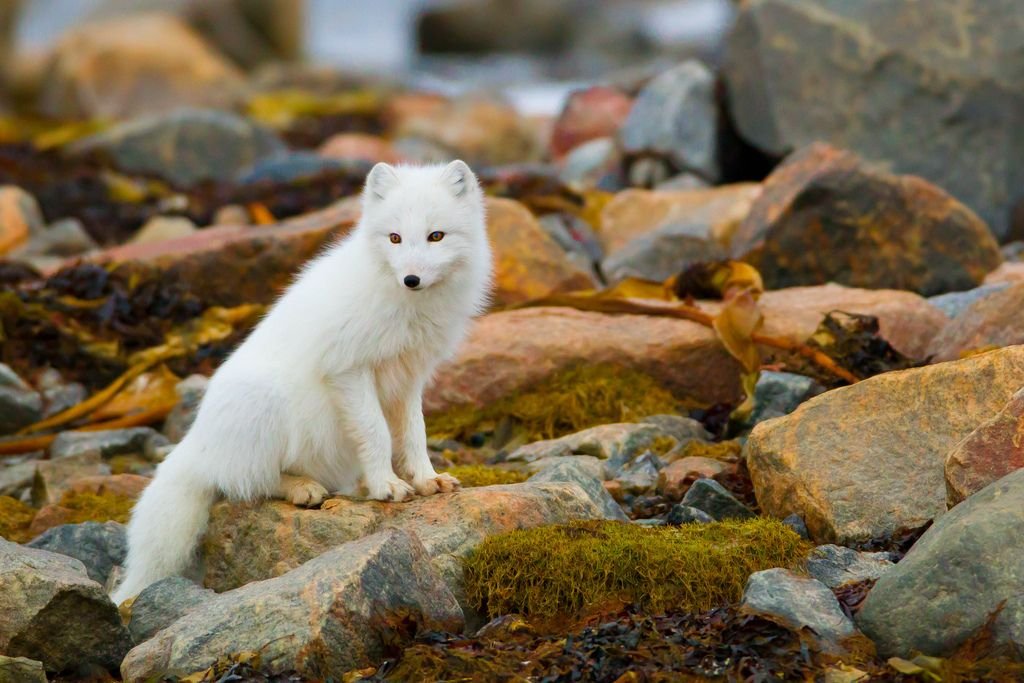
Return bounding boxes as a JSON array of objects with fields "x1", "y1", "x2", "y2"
[{"x1": 928, "y1": 282, "x2": 1024, "y2": 360}]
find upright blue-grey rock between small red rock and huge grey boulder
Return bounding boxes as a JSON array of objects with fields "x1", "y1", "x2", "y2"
[{"x1": 618, "y1": 59, "x2": 719, "y2": 180}]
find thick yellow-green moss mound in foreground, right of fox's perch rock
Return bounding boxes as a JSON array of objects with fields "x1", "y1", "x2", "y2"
[{"x1": 465, "y1": 518, "x2": 810, "y2": 617}]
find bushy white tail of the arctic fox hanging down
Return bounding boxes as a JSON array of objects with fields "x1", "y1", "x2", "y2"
[{"x1": 111, "y1": 456, "x2": 216, "y2": 604}]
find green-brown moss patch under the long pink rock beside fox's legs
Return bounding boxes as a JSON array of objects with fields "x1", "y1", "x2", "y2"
[{"x1": 427, "y1": 365, "x2": 689, "y2": 441}]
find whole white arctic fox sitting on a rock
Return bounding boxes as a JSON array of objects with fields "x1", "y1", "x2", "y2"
[{"x1": 113, "y1": 161, "x2": 492, "y2": 603}]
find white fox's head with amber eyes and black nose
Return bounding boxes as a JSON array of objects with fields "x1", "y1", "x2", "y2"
[{"x1": 360, "y1": 161, "x2": 489, "y2": 292}]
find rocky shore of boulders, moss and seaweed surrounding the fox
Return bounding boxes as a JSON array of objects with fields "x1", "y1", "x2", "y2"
[{"x1": 0, "y1": 0, "x2": 1024, "y2": 682}]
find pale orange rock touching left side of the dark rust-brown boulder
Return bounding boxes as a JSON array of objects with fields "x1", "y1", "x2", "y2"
[{"x1": 601, "y1": 182, "x2": 761, "y2": 256}]
